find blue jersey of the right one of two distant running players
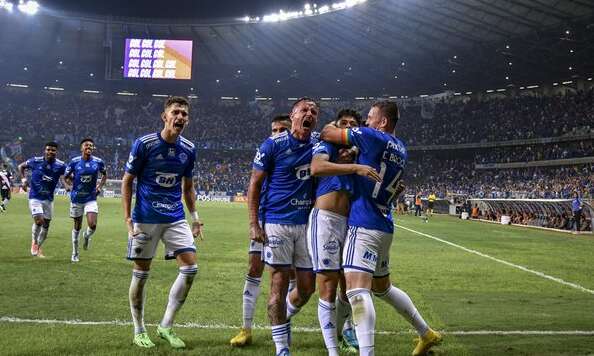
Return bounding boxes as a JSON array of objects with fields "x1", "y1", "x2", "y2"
[{"x1": 64, "y1": 156, "x2": 106, "y2": 204}]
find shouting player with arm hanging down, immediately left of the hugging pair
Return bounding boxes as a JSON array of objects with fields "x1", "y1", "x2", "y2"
[{"x1": 248, "y1": 98, "x2": 319, "y2": 356}]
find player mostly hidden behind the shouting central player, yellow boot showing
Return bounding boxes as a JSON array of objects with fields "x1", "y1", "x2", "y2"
[{"x1": 230, "y1": 115, "x2": 294, "y2": 347}]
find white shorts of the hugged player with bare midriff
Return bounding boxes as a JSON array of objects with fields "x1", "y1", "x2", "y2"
[{"x1": 307, "y1": 209, "x2": 347, "y2": 272}]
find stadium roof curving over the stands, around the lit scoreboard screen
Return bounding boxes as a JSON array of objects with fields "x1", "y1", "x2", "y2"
[{"x1": 0, "y1": 0, "x2": 594, "y2": 95}]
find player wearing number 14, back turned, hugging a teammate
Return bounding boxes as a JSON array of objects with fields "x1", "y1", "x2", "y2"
[{"x1": 322, "y1": 101, "x2": 441, "y2": 355}]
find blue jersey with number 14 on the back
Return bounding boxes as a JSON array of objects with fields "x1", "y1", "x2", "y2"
[{"x1": 347, "y1": 127, "x2": 407, "y2": 233}]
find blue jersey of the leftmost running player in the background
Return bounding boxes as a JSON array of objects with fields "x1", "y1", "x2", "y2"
[{"x1": 26, "y1": 157, "x2": 66, "y2": 201}]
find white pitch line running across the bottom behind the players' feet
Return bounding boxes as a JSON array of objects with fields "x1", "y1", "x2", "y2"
[{"x1": 0, "y1": 316, "x2": 594, "y2": 336}]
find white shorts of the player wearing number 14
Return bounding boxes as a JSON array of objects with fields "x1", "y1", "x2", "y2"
[{"x1": 342, "y1": 227, "x2": 381, "y2": 274}]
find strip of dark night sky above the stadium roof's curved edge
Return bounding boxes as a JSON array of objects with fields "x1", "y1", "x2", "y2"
[{"x1": 37, "y1": 0, "x2": 307, "y2": 19}]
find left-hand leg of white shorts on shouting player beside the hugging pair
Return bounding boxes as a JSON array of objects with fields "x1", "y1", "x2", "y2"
[{"x1": 263, "y1": 224, "x2": 294, "y2": 268}]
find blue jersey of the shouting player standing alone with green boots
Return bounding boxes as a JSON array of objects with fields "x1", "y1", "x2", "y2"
[{"x1": 126, "y1": 133, "x2": 196, "y2": 224}]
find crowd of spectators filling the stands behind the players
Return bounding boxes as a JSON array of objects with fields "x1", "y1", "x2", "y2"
[{"x1": 0, "y1": 89, "x2": 594, "y2": 210}]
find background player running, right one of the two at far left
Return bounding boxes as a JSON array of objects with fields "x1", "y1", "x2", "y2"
[{"x1": 64, "y1": 138, "x2": 107, "y2": 262}]
